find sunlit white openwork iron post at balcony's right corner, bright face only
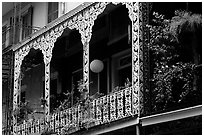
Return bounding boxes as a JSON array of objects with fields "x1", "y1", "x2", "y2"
[{"x1": 125, "y1": 2, "x2": 142, "y2": 117}]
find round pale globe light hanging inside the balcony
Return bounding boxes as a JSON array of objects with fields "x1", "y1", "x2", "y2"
[{"x1": 90, "y1": 59, "x2": 104, "y2": 73}]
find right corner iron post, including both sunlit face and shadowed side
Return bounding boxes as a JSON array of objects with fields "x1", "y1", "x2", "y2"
[{"x1": 125, "y1": 2, "x2": 149, "y2": 117}]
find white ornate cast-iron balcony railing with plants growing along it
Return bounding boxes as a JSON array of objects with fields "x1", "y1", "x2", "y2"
[{"x1": 10, "y1": 87, "x2": 139, "y2": 135}]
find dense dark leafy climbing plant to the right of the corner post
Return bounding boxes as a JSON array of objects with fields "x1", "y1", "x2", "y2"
[{"x1": 148, "y1": 12, "x2": 201, "y2": 111}]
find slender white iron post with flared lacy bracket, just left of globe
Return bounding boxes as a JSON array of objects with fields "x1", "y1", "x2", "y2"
[{"x1": 75, "y1": 2, "x2": 107, "y2": 92}]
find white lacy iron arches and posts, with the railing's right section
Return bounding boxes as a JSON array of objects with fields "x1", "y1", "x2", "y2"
[{"x1": 13, "y1": 2, "x2": 143, "y2": 134}]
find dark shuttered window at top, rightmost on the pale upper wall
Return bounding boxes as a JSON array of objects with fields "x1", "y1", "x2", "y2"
[{"x1": 48, "y1": 2, "x2": 58, "y2": 23}]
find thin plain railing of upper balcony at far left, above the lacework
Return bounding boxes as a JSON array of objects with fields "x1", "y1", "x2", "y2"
[{"x1": 2, "y1": 24, "x2": 40, "y2": 49}]
